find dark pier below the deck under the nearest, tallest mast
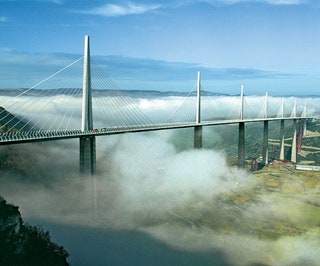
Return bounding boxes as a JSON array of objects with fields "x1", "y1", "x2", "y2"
[{"x1": 80, "y1": 137, "x2": 96, "y2": 175}]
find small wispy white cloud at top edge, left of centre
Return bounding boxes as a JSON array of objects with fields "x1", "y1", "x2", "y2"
[{"x1": 77, "y1": 2, "x2": 160, "y2": 17}]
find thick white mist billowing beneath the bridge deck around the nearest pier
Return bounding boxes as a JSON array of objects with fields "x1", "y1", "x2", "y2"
[{"x1": 0, "y1": 131, "x2": 249, "y2": 229}]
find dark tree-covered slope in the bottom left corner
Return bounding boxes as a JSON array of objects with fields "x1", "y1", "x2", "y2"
[{"x1": 0, "y1": 196, "x2": 69, "y2": 266}]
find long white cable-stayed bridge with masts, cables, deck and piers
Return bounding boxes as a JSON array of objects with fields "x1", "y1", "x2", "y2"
[{"x1": 0, "y1": 36, "x2": 311, "y2": 174}]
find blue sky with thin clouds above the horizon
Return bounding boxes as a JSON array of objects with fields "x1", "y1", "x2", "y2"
[{"x1": 0, "y1": 0, "x2": 320, "y2": 95}]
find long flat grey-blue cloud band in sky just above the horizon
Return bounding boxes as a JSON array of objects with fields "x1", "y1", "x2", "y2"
[{"x1": 0, "y1": 51, "x2": 303, "y2": 92}]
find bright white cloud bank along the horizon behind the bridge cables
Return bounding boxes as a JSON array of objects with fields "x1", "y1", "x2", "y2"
[{"x1": 0, "y1": 94, "x2": 320, "y2": 130}]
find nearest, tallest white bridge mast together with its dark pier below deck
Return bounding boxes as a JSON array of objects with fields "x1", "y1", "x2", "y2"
[{"x1": 80, "y1": 35, "x2": 96, "y2": 175}]
